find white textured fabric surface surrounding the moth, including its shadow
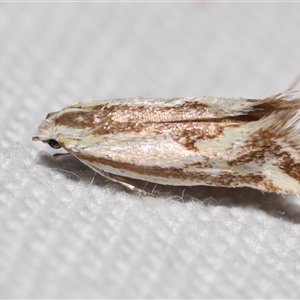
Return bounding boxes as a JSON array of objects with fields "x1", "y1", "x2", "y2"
[{"x1": 0, "y1": 2, "x2": 300, "y2": 298}]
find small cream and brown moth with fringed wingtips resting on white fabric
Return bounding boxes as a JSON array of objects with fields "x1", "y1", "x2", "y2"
[{"x1": 32, "y1": 82, "x2": 300, "y2": 196}]
